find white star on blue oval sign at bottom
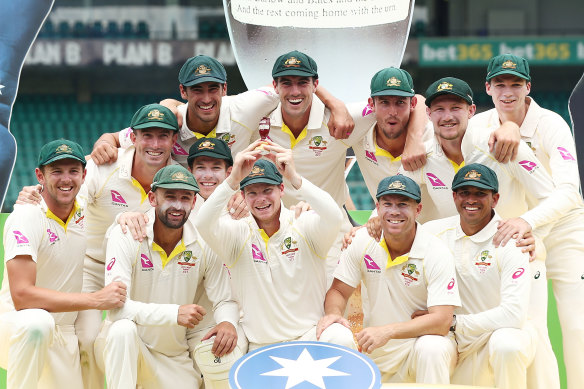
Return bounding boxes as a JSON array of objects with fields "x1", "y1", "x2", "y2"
[{"x1": 261, "y1": 348, "x2": 350, "y2": 389}]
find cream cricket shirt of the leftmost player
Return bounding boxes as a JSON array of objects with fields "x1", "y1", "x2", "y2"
[{"x1": 0, "y1": 201, "x2": 86, "y2": 325}]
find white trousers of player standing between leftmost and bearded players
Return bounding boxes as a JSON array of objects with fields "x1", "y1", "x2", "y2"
[{"x1": 75, "y1": 256, "x2": 105, "y2": 389}]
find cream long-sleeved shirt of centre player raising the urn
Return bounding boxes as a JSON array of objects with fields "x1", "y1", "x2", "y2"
[{"x1": 195, "y1": 178, "x2": 342, "y2": 343}]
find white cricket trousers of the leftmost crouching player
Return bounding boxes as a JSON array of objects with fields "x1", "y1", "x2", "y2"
[{"x1": 0, "y1": 309, "x2": 83, "y2": 389}]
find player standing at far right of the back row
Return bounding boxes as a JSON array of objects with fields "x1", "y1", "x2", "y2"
[{"x1": 473, "y1": 54, "x2": 584, "y2": 388}]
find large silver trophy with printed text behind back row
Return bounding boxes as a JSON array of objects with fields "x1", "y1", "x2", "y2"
[{"x1": 223, "y1": 0, "x2": 414, "y2": 102}]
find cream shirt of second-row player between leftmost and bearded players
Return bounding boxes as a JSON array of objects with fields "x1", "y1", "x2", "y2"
[{"x1": 78, "y1": 146, "x2": 173, "y2": 263}]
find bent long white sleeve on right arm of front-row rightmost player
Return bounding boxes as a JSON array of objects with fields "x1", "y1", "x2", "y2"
[{"x1": 456, "y1": 241, "x2": 531, "y2": 336}]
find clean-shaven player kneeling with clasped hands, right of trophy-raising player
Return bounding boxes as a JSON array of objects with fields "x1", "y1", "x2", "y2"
[{"x1": 317, "y1": 176, "x2": 460, "y2": 384}]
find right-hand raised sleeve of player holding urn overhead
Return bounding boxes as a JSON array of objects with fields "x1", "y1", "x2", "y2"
[{"x1": 290, "y1": 177, "x2": 343, "y2": 258}]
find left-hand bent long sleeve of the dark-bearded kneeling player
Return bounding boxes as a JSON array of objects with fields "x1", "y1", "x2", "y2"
[{"x1": 105, "y1": 226, "x2": 179, "y2": 326}]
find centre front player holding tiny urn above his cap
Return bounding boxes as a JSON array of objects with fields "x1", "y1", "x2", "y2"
[{"x1": 195, "y1": 141, "x2": 342, "y2": 350}]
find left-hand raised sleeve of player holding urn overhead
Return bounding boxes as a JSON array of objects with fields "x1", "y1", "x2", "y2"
[{"x1": 195, "y1": 181, "x2": 249, "y2": 266}]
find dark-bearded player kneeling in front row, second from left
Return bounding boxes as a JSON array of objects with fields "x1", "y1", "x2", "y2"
[{"x1": 96, "y1": 165, "x2": 245, "y2": 388}]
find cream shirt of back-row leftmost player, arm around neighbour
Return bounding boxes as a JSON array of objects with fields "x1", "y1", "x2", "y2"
[{"x1": 119, "y1": 88, "x2": 280, "y2": 168}]
